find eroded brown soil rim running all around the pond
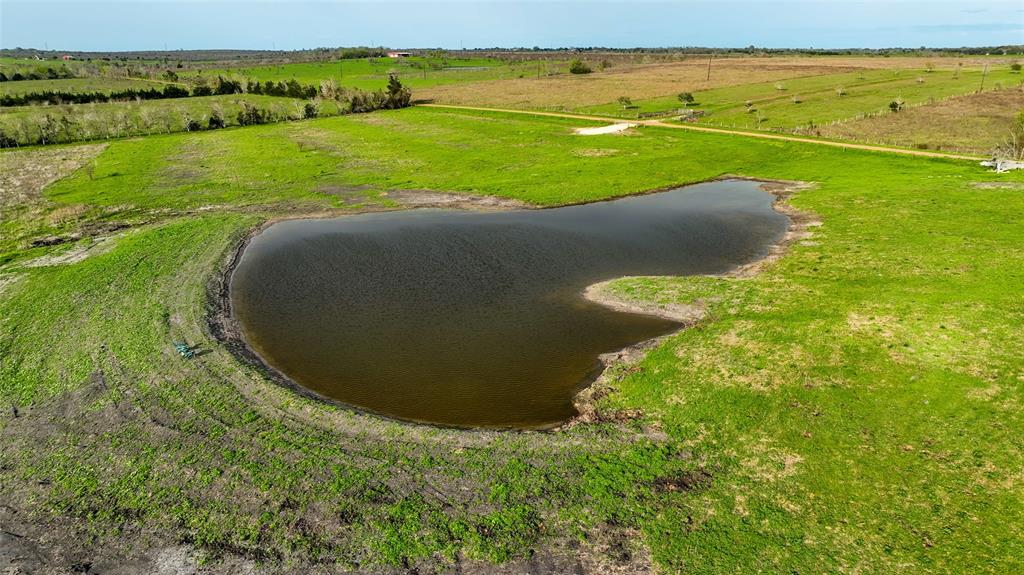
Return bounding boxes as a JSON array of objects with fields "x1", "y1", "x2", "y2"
[{"x1": 206, "y1": 174, "x2": 818, "y2": 432}]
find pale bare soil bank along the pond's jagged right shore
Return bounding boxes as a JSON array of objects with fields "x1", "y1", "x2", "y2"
[{"x1": 573, "y1": 176, "x2": 821, "y2": 429}]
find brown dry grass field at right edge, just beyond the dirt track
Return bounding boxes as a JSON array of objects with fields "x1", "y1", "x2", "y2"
[{"x1": 820, "y1": 89, "x2": 1024, "y2": 153}]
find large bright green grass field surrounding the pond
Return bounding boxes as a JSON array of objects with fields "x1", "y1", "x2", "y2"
[{"x1": 0, "y1": 108, "x2": 1024, "y2": 574}]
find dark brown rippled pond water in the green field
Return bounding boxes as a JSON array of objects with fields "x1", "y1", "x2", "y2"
[{"x1": 230, "y1": 180, "x2": 787, "y2": 428}]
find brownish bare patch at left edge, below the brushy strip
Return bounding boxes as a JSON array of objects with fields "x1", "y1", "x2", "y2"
[{"x1": 0, "y1": 143, "x2": 106, "y2": 208}]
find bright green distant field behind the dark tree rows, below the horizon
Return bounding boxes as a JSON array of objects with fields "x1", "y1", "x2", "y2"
[{"x1": 180, "y1": 56, "x2": 564, "y2": 90}]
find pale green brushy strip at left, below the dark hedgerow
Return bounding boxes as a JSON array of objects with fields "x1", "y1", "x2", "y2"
[{"x1": 0, "y1": 94, "x2": 338, "y2": 144}]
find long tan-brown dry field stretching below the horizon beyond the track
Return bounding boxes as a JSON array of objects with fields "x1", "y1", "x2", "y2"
[{"x1": 416, "y1": 56, "x2": 1007, "y2": 109}]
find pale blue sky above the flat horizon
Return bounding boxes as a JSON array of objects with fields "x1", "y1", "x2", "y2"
[{"x1": 0, "y1": 0, "x2": 1024, "y2": 50}]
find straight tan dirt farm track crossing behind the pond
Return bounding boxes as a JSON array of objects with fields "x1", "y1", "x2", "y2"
[{"x1": 418, "y1": 103, "x2": 985, "y2": 161}]
